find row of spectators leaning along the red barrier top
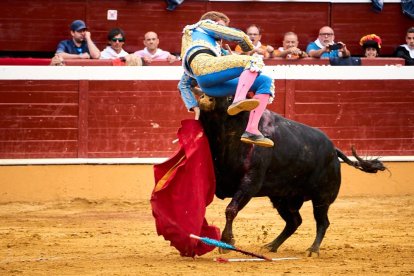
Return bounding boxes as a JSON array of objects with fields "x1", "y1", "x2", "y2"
[{"x1": 52, "y1": 20, "x2": 414, "y2": 65}]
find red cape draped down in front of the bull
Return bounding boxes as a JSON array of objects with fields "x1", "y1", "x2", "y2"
[{"x1": 151, "y1": 120, "x2": 220, "y2": 257}]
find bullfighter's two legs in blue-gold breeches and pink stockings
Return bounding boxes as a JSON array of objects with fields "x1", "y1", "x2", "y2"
[{"x1": 191, "y1": 54, "x2": 275, "y2": 147}]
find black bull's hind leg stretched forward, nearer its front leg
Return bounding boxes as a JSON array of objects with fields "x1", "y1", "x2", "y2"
[{"x1": 265, "y1": 198, "x2": 303, "y2": 252}]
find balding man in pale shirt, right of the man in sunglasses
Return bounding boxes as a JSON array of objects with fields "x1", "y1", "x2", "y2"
[{"x1": 134, "y1": 32, "x2": 177, "y2": 64}]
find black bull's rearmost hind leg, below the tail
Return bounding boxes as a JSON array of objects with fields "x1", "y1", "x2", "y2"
[{"x1": 306, "y1": 201, "x2": 330, "y2": 257}]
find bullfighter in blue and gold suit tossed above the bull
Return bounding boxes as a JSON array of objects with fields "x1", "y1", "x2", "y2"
[{"x1": 178, "y1": 11, "x2": 274, "y2": 147}]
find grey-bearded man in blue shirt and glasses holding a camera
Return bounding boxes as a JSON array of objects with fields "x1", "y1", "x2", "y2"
[{"x1": 306, "y1": 26, "x2": 351, "y2": 58}]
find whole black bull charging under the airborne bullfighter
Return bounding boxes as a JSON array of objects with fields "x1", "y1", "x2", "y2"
[{"x1": 200, "y1": 96, "x2": 385, "y2": 256}]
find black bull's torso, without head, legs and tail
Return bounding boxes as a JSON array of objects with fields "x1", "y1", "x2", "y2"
[{"x1": 202, "y1": 104, "x2": 340, "y2": 198}]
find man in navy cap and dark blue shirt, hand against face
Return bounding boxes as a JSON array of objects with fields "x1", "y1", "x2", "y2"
[{"x1": 56, "y1": 20, "x2": 101, "y2": 60}]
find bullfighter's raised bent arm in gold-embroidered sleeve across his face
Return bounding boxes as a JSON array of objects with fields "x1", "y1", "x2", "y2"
[{"x1": 198, "y1": 20, "x2": 254, "y2": 52}]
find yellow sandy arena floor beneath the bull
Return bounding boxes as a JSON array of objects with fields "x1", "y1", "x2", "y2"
[{"x1": 0, "y1": 196, "x2": 414, "y2": 276}]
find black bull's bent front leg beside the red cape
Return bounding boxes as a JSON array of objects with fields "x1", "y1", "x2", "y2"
[{"x1": 220, "y1": 191, "x2": 252, "y2": 253}]
